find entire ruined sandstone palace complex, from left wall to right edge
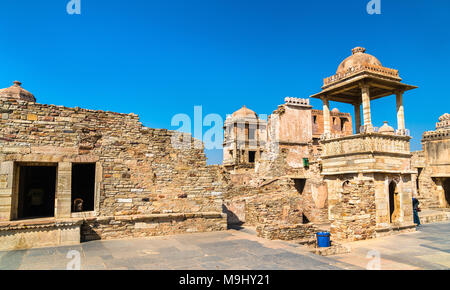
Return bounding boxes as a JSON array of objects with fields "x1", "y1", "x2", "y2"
[{"x1": 0, "y1": 47, "x2": 442, "y2": 250}]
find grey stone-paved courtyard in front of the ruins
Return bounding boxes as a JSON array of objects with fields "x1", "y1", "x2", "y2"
[{"x1": 0, "y1": 222, "x2": 450, "y2": 270}]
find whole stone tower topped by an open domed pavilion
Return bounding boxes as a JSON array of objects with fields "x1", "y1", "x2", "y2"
[{"x1": 311, "y1": 47, "x2": 416, "y2": 241}]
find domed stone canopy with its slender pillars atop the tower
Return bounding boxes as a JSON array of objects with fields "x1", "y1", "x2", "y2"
[{"x1": 311, "y1": 47, "x2": 417, "y2": 136}]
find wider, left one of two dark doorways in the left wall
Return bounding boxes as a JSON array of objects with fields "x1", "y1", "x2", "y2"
[{"x1": 17, "y1": 165, "x2": 57, "y2": 219}]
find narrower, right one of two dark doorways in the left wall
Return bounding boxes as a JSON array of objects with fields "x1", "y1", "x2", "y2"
[{"x1": 72, "y1": 163, "x2": 95, "y2": 212}]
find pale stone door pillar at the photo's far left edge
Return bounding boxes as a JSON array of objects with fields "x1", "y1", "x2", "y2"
[{"x1": 0, "y1": 161, "x2": 14, "y2": 221}]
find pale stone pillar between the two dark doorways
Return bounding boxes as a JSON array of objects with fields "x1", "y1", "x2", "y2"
[{"x1": 55, "y1": 162, "x2": 72, "y2": 218}]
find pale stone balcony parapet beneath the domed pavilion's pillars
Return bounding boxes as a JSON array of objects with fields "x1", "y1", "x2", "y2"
[{"x1": 321, "y1": 133, "x2": 411, "y2": 157}]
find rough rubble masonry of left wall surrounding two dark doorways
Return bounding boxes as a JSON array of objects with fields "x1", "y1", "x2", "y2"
[{"x1": 0, "y1": 99, "x2": 224, "y2": 236}]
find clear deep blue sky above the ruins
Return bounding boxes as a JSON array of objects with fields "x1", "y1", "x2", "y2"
[{"x1": 0, "y1": 0, "x2": 450, "y2": 163}]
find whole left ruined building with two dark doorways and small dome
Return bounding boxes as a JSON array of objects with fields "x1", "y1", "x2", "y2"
[{"x1": 0, "y1": 82, "x2": 227, "y2": 250}]
